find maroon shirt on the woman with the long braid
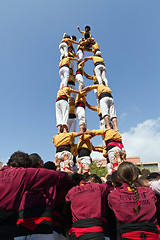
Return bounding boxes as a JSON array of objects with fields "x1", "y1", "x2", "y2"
[{"x1": 108, "y1": 183, "x2": 156, "y2": 223}]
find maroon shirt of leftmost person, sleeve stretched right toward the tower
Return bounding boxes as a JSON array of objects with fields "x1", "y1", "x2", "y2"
[{"x1": 0, "y1": 166, "x2": 68, "y2": 210}]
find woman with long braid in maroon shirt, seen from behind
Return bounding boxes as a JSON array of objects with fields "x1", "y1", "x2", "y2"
[{"x1": 108, "y1": 162, "x2": 160, "y2": 240}]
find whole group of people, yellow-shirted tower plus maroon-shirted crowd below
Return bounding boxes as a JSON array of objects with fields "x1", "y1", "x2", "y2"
[{"x1": 0, "y1": 26, "x2": 160, "y2": 240}]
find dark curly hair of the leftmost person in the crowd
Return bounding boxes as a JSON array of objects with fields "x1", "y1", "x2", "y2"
[{"x1": 7, "y1": 151, "x2": 32, "y2": 168}]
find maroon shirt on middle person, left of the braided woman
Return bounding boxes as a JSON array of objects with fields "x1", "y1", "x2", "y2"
[{"x1": 66, "y1": 181, "x2": 109, "y2": 222}]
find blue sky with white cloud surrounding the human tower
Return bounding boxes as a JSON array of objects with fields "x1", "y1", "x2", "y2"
[{"x1": 0, "y1": 0, "x2": 160, "y2": 162}]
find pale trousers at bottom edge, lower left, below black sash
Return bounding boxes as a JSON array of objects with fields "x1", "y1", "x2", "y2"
[{"x1": 14, "y1": 233, "x2": 55, "y2": 240}]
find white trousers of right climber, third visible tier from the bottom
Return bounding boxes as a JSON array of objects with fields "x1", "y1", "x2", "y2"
[{"x1": 94, "y1": 64, "x2": 108, "y2": 86}]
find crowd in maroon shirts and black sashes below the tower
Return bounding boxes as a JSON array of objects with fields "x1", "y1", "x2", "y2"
[{"x1": 0, "y1": 152, "x2": 160, "y2": 240}]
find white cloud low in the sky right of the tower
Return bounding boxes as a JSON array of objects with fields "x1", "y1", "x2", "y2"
[{"x1": 122, "y1": 118, "x2": 160, "y2": 162}]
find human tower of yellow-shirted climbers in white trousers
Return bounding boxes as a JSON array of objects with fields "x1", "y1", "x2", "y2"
[{"x1": 53, "y1": 26, "x2": 126, "y2": 174}]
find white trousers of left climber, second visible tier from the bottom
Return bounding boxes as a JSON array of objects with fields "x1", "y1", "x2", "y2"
[{"x1": 56, "y1": 99, "x2": 69, "y2": 126}]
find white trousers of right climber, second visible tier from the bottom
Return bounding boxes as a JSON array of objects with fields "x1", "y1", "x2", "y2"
[{"x1": 99, "y1": 97, "x2": 116, "y2": 120}]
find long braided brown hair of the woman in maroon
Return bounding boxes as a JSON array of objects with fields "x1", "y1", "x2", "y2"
[{"x1": 117, "y1": 162, "x2": 140, "y2": 214}]
